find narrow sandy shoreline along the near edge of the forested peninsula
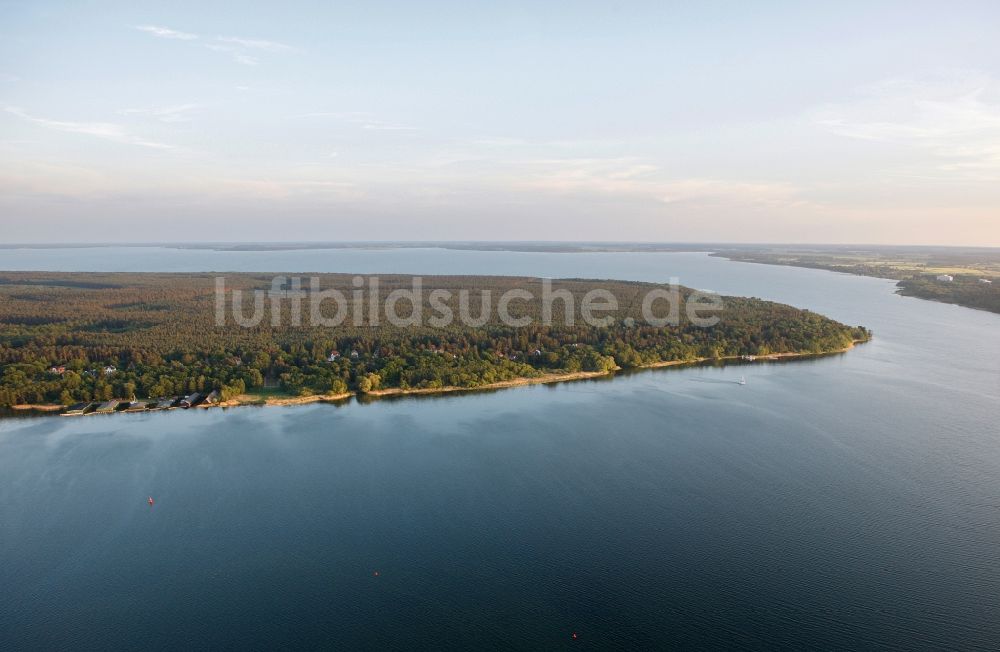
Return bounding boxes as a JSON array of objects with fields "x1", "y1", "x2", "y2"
[{"x1": 11, "y1": 340, "x2": 870, "y2": 416}]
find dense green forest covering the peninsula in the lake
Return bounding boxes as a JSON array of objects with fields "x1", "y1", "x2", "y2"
[{"x1": 0, "y1": 272, "x2": 868, "y2": 406}]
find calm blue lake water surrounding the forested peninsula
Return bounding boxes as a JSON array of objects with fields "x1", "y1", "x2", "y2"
[{"x1": 0, "y1": 249, "x2": 1000, "y2": 650}]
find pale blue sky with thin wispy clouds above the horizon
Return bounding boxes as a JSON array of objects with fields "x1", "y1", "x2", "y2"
[{"x1": 0, "y1": 0, "x2": 1000, "y2": 246}]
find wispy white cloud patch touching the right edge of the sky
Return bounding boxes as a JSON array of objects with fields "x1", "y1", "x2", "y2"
[{"x1": 811, "y1": 73, "x2": 1000, "y2": 175}]
